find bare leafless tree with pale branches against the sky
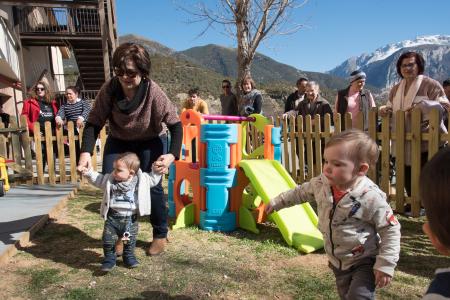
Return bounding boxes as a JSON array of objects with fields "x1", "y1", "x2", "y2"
[{"x1": 183, "y1": 0, "x2": 308, "y2": 88}]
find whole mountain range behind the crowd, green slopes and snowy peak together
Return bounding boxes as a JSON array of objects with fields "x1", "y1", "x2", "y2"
[{"x1": 68, "y1": 34, "x2": 450, "y2": 116}]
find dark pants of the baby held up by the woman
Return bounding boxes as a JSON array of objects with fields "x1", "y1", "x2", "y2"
[{"x1": 102, "y1": 209, "x2": 139, "y2": 260}]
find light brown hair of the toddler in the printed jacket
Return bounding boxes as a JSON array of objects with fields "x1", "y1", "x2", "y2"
[{"x1": 325, "y1": 129, "x2": 380, "y2": 168}]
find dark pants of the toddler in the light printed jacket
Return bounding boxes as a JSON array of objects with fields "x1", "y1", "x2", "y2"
[{"x1": 329, "y1": 258, "x2": 375, "y2": 300}]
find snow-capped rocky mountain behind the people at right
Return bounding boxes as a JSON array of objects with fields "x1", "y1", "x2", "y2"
[{"x1": 328, "y1": 35, "x2": 450, "y2": 88}]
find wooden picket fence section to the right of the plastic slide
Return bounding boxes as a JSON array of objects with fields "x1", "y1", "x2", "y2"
[{"x1": 257, "y1": 109, "x2": 450, "y2": 216}]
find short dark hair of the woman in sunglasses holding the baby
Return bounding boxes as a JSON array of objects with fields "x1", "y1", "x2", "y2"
[{"x1": 112, "y1": 43, "x2": 152, "y2": 78}]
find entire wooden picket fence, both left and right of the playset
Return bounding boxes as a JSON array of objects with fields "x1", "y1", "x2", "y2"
[{"x1": 0, "y1": 109, "x2": 450, "y2": 216}]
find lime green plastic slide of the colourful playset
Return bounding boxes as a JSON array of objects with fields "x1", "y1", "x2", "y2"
[{"x1": 239, "y1": 159, "x2": 323, "y2": 253}]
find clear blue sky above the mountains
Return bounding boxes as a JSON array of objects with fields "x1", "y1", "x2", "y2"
[{"x1": 116, "y1": 0, "x2": 450, "y2": 72}]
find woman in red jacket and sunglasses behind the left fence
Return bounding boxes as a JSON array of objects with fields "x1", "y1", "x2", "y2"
[{"x1": 22, "y1": 81, "x2": 58, "y2": 166}]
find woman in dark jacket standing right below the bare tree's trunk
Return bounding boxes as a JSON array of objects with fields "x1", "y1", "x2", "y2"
[{"x1": 239, "y1": 75, "x2": 263, "y2": 117}]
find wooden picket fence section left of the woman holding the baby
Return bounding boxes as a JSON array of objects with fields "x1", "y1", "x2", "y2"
[{"x1": 0, "y1": 116, "x2": 106, "y2": 184}]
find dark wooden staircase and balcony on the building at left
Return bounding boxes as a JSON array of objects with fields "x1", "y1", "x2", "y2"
[{"x1": 14, "y1": 0, "x2": 117, "y2": 90}]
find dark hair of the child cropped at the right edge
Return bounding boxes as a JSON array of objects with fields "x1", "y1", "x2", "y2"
[{"x1": 419, "y1": 147, "x2": 450, "y2": 249}]
